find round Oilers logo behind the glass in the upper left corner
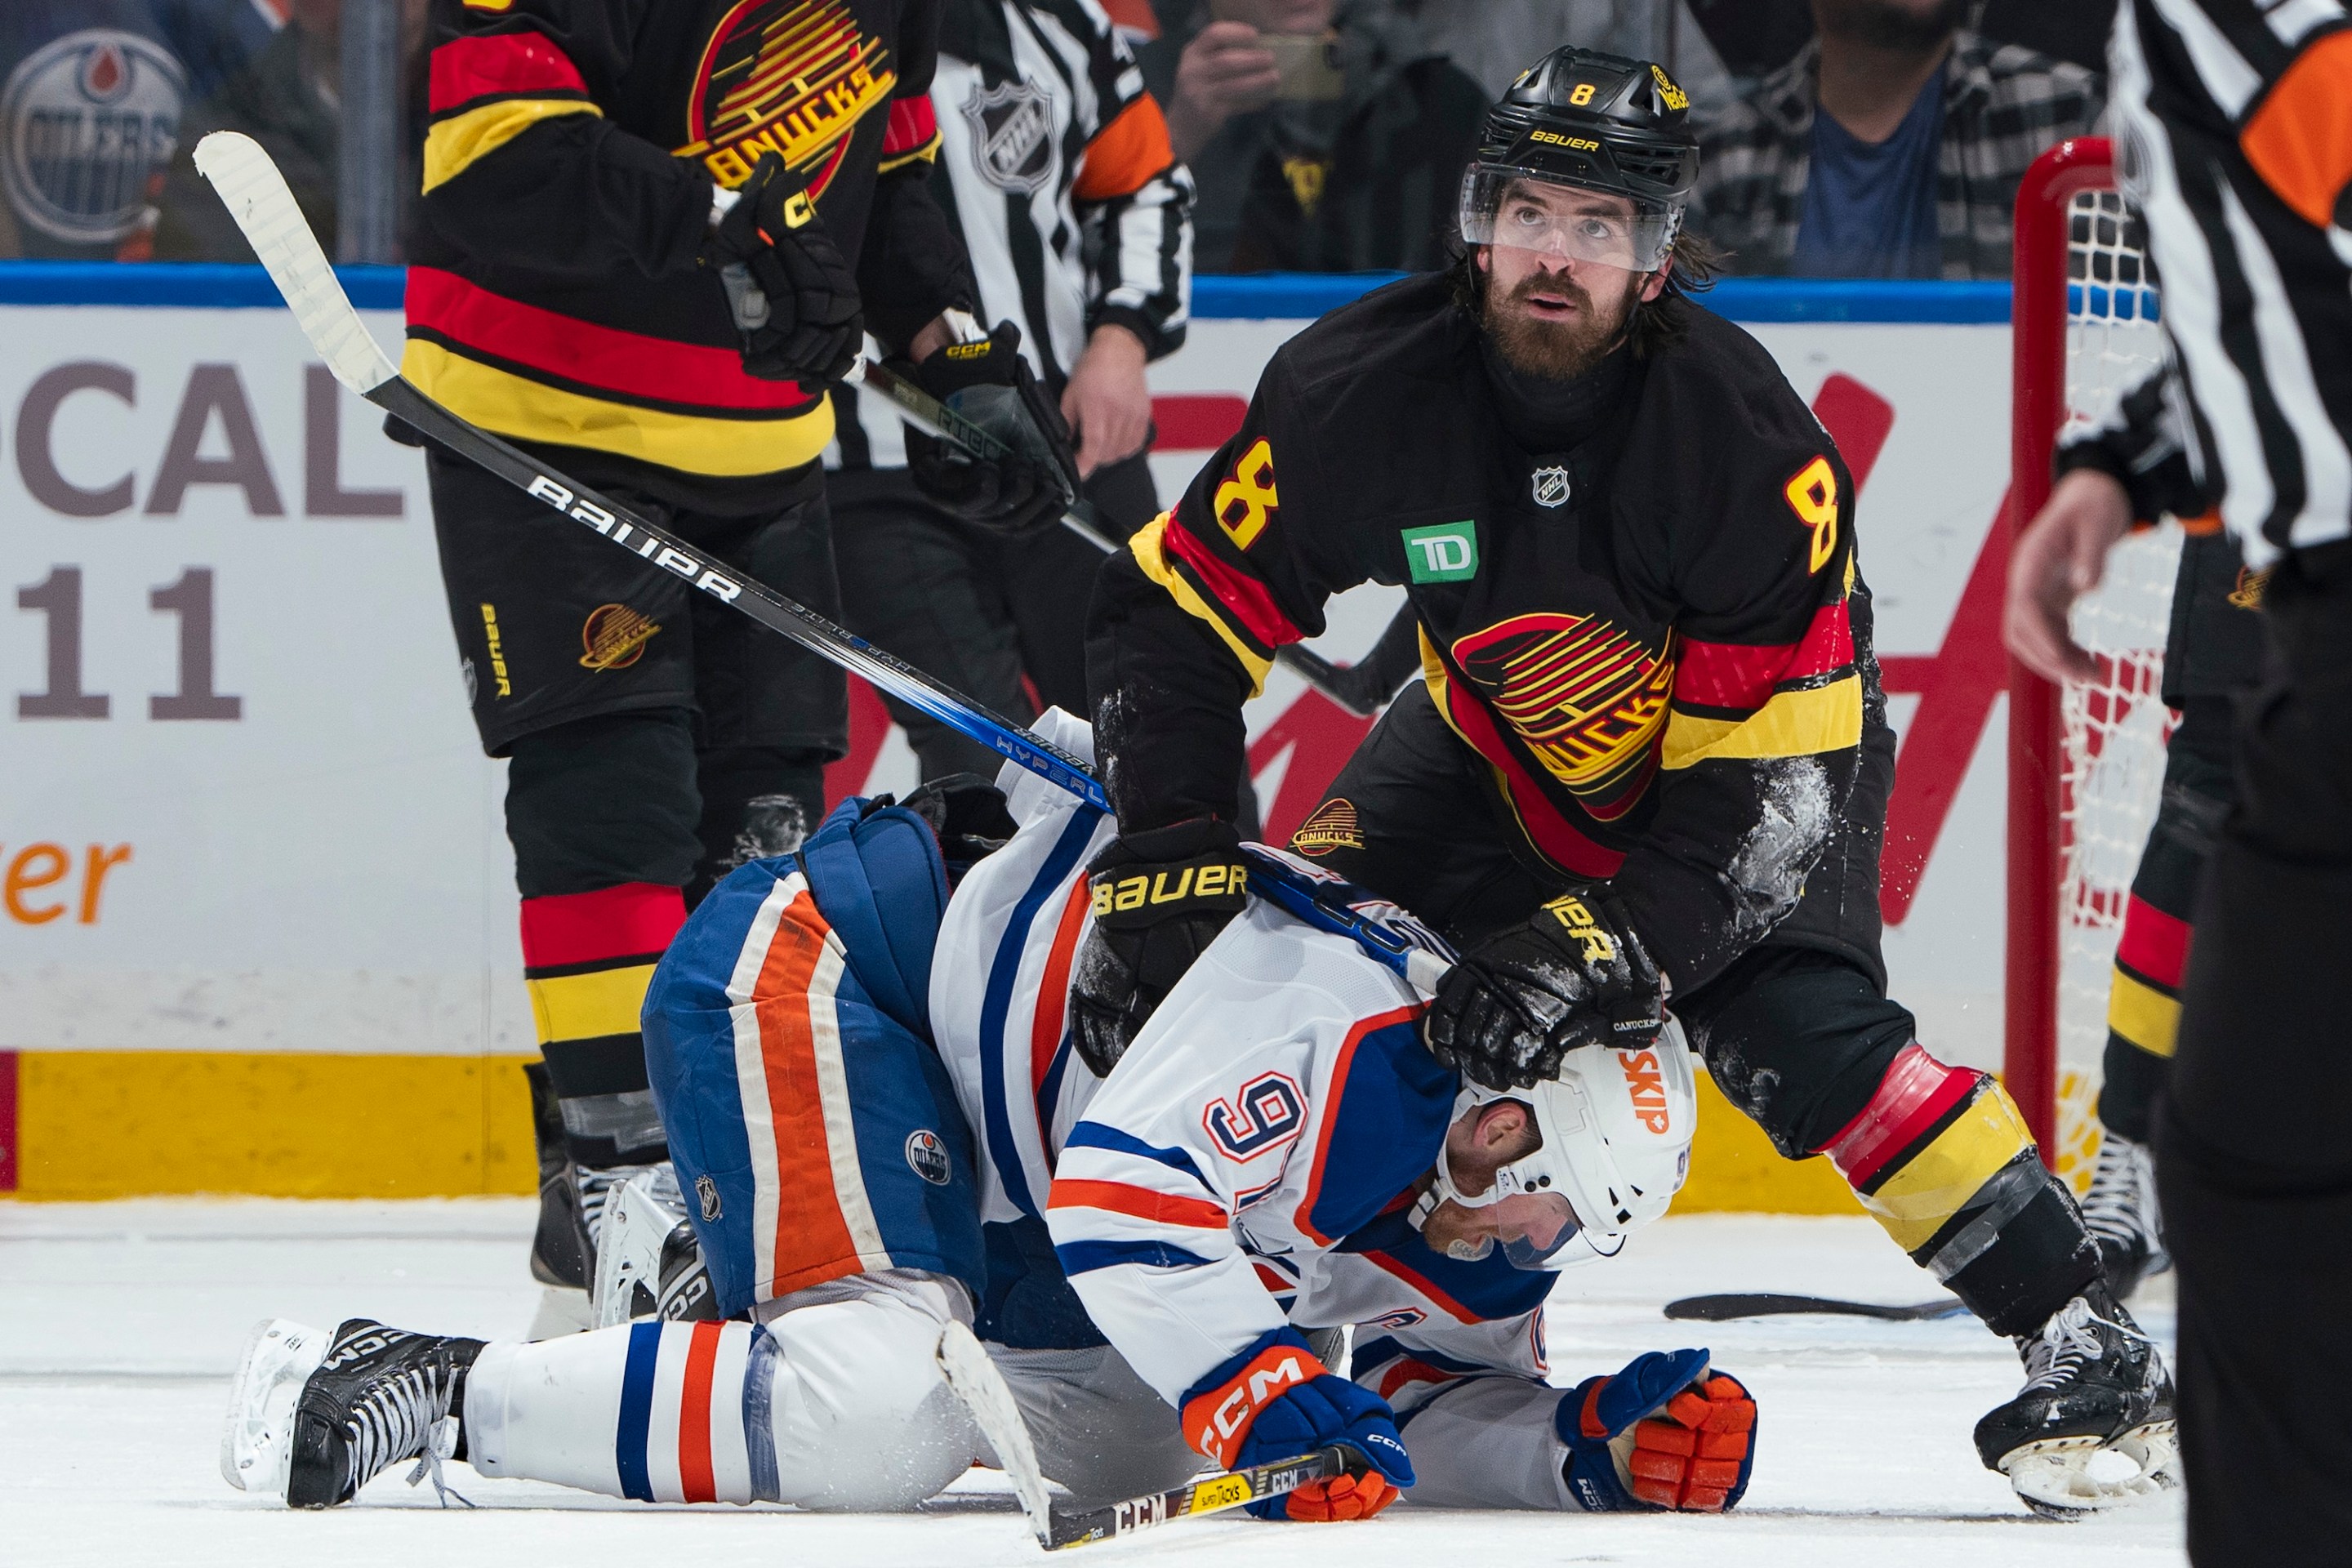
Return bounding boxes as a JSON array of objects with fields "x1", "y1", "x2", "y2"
[{"x1": 0, "y1": 29, "x2": 188, "y2": 244}]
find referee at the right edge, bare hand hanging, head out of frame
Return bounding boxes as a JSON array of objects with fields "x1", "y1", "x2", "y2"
[{"x1": 2007, "y1": 0, "x2": 2352, "y2": 1568}]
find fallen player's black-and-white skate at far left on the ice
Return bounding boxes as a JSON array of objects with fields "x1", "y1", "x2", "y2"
[{"x1": 221, "y1": 1316, "x2": 482, "y2": 1509}]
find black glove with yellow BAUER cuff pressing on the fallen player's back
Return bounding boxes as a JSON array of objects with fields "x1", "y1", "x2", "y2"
[{"x1": 1070, "y1": 816, "x2": 1249, "y2": 1076}]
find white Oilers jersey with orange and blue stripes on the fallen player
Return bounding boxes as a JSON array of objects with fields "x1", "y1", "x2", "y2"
[{"x1": 931, "y1": 712, "x2": 1608, "y2": 1507}]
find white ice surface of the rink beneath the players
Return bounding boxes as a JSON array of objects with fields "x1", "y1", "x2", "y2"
[{"x1": 0, "y1": 1199, "x2": 2185, "y2": 1568}]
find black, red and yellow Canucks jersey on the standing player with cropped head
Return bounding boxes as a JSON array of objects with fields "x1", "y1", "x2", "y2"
[{"x1": 402, "y1": 0, "x2": 969, "y2": 493}]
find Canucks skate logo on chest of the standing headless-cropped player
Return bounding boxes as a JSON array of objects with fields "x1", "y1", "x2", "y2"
[{"x1": 677, "y1": 0, "x2": 898, "y2": 203}]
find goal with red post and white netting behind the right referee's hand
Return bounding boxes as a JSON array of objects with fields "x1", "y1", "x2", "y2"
[{"x1": 2009, "y1": 139, "x2": 2180, "y2": 1192}]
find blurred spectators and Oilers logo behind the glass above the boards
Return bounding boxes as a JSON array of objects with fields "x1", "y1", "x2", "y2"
[{"x1": 0, "y1": 0, "x2": 2114, "y2": 278}]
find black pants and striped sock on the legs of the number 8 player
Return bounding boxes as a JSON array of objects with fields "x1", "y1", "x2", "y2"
[{"x1": 1294, "y1": 684, "x2": 2098, "y2": 1335}]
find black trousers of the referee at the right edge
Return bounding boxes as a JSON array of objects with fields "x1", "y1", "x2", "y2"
[{"x1": 2157, "y1": 543, "x2": 2352, "y2": 1568}]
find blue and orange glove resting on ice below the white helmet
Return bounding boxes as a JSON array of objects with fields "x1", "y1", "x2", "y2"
[{"x1": 1552, "y1": 1349, "x2": 1757, "y2": 1514}]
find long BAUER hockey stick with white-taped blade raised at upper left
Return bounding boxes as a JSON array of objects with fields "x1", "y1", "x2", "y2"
[{"x1": 195, "y1": 131, "x2": 1446, "y2": 992}]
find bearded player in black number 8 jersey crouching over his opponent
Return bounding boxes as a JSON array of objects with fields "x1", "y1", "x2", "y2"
[{"x1": 1072, "y1": 49, "x2": 2171, "y2": 1512}]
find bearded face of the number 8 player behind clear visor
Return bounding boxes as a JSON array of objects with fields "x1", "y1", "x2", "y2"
[{"x1": 1477, "y1": 179, "x2": 1665, "y2": 381}]
